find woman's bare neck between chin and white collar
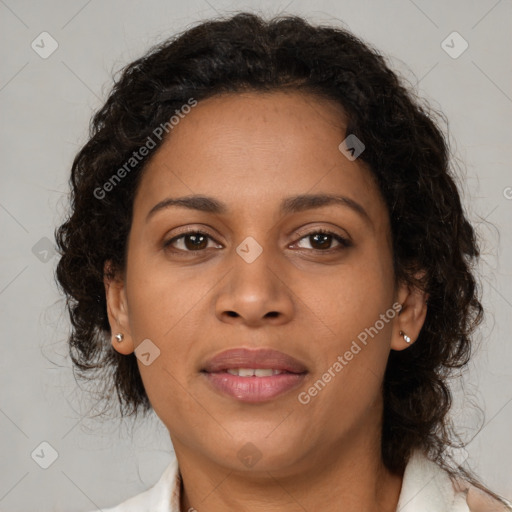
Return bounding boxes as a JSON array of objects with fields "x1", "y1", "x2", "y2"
[{"x1": 173, "y1": 439, "x2": 402, "y2": 512}]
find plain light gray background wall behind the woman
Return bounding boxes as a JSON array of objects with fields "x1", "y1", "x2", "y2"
[{"x1": 0, "y1": 0, "x2": 512, "y2": 512}]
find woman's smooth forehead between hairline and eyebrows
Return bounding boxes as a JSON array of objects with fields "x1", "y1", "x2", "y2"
[{"x1": 136, "y1": 92, "x2": 383, "y2": 226}]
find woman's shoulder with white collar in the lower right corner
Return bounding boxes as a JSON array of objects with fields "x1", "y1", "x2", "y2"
[{"x1": 397, "y1": 451, "x2": 512, "y2": 512}]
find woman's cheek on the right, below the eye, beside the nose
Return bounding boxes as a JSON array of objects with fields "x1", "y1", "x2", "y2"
[{"x1": 292, "y1": 248, "x2": 396, "y2": 400}]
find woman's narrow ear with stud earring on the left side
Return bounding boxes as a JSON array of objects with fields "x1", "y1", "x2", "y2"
[{"x1": 103, "y1": 261, "x2": 135, "y2": 355}]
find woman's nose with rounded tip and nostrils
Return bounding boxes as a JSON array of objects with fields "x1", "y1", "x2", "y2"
[{"x1": 215, "y1": 244, "x2": 295, "y2": 327}]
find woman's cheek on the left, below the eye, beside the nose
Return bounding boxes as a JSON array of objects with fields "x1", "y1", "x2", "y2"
[{"x1": 123, "y1": 252, "x2": 206, "y2": 394}]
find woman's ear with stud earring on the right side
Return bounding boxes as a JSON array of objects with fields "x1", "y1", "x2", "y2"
[{"x1": 391, "y1": 272, "x2": 428, "y2": 350}]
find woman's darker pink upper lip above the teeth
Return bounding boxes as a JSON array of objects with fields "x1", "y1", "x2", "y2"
[{"x1": 202, "y1": 348, "x2": 307, "y2": 373}]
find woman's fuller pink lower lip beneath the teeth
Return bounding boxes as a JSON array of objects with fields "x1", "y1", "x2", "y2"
[{"x1": 202, "y1": 372, "x2": 306, "y2": 402}]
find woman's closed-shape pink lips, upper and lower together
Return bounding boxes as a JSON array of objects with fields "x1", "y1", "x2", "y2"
[{"x1": 201, "y1": 348, "x2": 307, "y2": 402}]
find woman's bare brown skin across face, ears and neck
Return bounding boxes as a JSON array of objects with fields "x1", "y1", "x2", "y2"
[{"x1": 105, "y1": 92, "x2": 426, "y2": 512}]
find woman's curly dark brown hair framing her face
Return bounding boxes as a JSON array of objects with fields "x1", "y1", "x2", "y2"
[{"x1": 55, "y1": 13, "x2": 490, "y2": 484}]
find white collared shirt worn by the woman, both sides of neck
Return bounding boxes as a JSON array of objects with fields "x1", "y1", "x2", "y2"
[{"x1": 90, "y1": 452, "x2": 512, "y2": 512}]
